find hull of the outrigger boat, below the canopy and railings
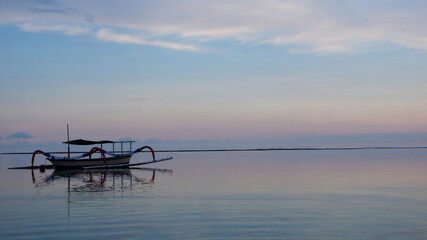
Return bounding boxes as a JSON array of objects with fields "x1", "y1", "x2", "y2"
[{"x1": 47, "y1": 156, "x2": 131, "y2": 168}]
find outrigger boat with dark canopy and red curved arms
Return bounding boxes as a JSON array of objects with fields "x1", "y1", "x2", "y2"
[{"x1": 31, "y1": 139, "x2": 173, "y2": 168}]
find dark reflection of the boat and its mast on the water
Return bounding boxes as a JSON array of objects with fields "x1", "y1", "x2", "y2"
[{"x1": 31, "y1": 168, "x2": 173, "y2": 223}]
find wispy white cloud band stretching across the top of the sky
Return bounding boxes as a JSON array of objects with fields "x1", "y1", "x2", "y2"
[{"x1": 0, "y1": 0, "x2": 427, "y2": 54}]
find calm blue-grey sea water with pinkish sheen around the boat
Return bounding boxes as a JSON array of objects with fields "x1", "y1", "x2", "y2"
[{"x1": 0, "y1": 149, "x2": 427, "y2": 239}]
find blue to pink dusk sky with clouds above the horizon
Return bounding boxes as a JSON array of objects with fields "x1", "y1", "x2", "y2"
[{"x1": 0, "y1": 0, "x2": 427, "y2": 149}]
